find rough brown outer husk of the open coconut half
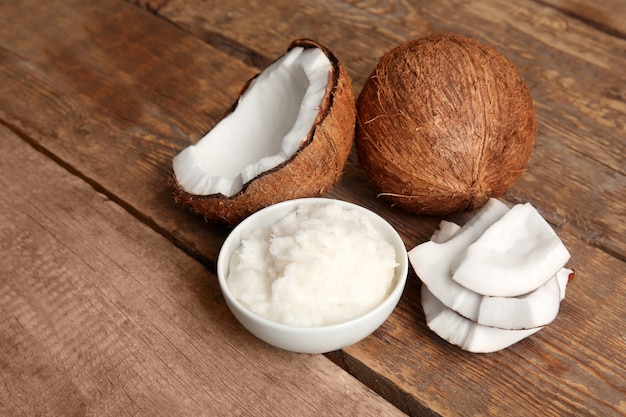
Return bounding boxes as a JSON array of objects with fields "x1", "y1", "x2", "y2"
[{"x1": 170, "y1": 39, "x2": 356, "y2": 225}]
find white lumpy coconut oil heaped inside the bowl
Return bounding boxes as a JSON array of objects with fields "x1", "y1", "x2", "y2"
[{"x1": 226, "y1": 202, "x2": 398, "y2": 327}]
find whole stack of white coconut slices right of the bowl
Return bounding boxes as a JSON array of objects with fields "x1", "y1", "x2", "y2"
[{"x1": 409, "y1": 199, "x2": 573, "y2": 353}]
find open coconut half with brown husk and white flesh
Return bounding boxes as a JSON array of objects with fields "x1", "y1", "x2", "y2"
[{"x1": 170, "y1": 39, "x2": 356, "y2": 225}]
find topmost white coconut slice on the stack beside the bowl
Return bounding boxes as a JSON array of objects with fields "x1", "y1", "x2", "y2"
[{"x1": 452, "y1": 203, "x2": 570, "y2": 297}]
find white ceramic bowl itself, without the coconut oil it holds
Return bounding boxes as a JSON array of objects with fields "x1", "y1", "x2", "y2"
[{"x1": 217, "y1": 198, "x2": 408, "y2": 353}]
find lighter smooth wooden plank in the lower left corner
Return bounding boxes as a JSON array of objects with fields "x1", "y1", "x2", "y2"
[{"x1": 0, "y1": 126, "x2": 401, "y2": 416}]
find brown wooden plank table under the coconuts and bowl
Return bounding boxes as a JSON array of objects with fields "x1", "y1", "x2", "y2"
[{"x1": 0, "y1": 0, "x2": 626, "y2": 416}]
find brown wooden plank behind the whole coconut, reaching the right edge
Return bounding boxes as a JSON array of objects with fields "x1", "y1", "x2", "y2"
[{"x1": 151, "y1": 0, "x2": 626, "y2": 259}]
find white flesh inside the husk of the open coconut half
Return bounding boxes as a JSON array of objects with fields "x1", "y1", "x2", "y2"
[{"x1": 173, "y1": 47, "x2": 332, "y2": 197}]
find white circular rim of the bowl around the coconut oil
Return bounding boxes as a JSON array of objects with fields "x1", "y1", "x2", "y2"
[{"x1": 216, "y1": 197, "x2": 409, "y2": 333}]
